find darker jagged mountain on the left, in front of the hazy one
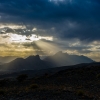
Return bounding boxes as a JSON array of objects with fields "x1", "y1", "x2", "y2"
[{"x1": 1, "y1": 55, "x2": 52, "y2": 70}]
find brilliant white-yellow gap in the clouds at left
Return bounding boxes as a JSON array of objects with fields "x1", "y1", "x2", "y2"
[{"x1": 0, "y1": 33, "x2": 53, "y2": 43}]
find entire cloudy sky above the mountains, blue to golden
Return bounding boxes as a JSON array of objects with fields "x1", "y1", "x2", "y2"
[{"x1": 0, "y1": 0, "x2": 100, "y2": 61}]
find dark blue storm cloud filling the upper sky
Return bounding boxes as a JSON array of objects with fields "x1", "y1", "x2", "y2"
[{"x1": 0, "y1": 0, "x2": 100, "y2": 41}]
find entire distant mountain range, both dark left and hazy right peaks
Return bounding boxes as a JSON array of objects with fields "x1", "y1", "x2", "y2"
[{"x1": 0, "y1": 52, "x2": 94, "y2": 71}]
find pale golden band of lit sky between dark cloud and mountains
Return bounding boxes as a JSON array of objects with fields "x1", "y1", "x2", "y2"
[{"x1": 0, "y1": 24, "x2": 100, "y2": 61}]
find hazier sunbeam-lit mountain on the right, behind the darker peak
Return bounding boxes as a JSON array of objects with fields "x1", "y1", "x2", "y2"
[{"x1": 44, "y1": 51, "x2": 94, "y2": 67}]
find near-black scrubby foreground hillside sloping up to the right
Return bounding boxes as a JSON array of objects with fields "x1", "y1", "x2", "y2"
[{"x1": 0, "y1": 63, "x2": 100, "y2": 100}]
